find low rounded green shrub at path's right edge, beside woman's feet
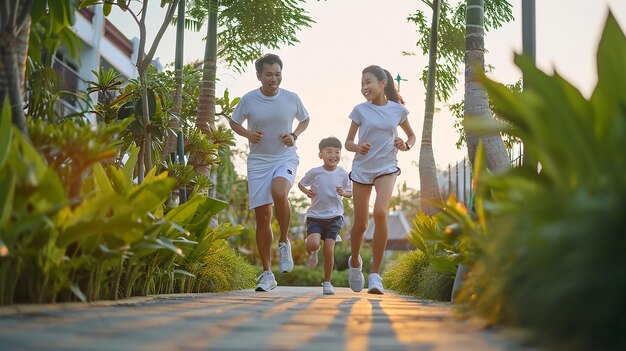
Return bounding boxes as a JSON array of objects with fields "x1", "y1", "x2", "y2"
[{"x1": 383, "y1": 250, "x2": 454, "y2": 301}]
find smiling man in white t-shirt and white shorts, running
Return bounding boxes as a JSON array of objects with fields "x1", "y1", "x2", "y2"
[{"x1": 230, "y1": 54, "x2": 309, "y2": 291}]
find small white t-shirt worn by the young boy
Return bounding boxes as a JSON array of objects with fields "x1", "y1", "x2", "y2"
[{"x1": 300, "y1": 166, "x2": 352, "y2": 219}]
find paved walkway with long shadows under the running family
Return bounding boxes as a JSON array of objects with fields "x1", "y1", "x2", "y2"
[{"x1": 0, "y1": 286, "x2": 530, "y2": 351}]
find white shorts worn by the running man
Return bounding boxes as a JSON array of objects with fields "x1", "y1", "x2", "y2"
[{"x1": 248, "y1": 156, "x2": 299, "y2": 209}]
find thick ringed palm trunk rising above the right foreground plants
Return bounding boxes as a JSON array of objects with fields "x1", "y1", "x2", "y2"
[{"x1": 464, "y1": 0, "x2": 510, "y2": 171}]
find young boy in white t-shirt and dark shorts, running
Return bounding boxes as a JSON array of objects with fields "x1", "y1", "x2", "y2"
[{"x1": 298, "y1": 137, "x2": 352, "y2": 295}]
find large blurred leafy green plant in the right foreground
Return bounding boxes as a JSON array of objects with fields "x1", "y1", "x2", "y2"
[{"x1": 450, "y1": 14, "x2": 626, "y2": 350}]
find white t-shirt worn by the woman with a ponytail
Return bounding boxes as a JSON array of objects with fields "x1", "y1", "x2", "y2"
[{"x1": 349, "y1": 101, "x2": 409, "y2": 173}]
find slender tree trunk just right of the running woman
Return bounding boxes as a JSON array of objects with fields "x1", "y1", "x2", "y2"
[{"x1": 419, "y1": 0, "x2": 441, "y2": 216}]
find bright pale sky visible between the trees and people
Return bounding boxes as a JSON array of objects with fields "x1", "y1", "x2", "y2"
[{"x1": 109, "y1": 0, "x2": 626, "y2": 189}]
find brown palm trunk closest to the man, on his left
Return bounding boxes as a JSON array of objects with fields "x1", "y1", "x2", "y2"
[{"x1": 190, "y1": 0, "x2": 219, "y2": 196}]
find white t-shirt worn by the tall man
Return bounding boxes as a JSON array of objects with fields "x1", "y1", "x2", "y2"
[{"x1": 231, "y1": 89, "x2": 309, "y2": 159}]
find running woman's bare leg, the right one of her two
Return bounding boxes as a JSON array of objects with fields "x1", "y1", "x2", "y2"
[{"x1": 370, "y1": 174, "x2": 398, "y2": 273}]
